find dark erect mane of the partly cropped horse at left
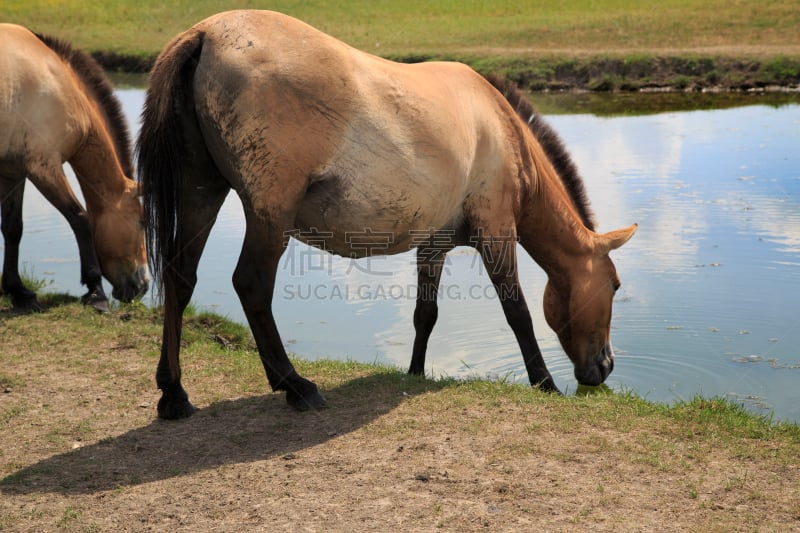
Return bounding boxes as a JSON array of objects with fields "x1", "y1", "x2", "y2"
[{"x1": 36, "y1": 33, "x2": 134, "y2": 179}]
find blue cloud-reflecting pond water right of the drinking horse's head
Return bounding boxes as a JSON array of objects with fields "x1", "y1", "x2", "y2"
[{"x1": 554, "y1": 106, "x2": 800, "y2": 420}]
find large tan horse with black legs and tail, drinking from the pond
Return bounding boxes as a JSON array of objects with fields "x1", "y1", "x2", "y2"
[{"x1": 137, "y1": 11, "x2": 636, "y2": 418}]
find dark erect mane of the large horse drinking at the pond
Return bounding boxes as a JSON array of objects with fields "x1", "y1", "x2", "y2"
[{"x1": 486, "y1": 76, "x2": 595, "y2": 231}]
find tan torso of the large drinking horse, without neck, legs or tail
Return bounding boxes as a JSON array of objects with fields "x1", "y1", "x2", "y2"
[{"x1": 184, "y1": 11, "x2": 516, "y2": 253}]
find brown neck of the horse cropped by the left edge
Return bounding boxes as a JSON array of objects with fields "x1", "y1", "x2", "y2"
[{"x1": 69, "y1": 105, "x2": 126, "y2": 213}]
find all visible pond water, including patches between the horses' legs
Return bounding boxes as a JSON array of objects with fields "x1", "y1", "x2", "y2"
[{"x1": 7, "y1": 89, "x2": 800, "y2": 421}]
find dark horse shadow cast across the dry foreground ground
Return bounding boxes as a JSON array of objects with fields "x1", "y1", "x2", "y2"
[{"x1": 0, "y1": 373, "x2": 453, "y2": 495}]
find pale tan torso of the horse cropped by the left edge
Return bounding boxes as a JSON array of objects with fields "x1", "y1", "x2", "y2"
[{"x1": 0, "y1": 24, "x2": 85, "y2": 169}]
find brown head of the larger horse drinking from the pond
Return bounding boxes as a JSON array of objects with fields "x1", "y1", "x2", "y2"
[{"x1": 544, "y1": 225, "x2": 637, "y2": 385}]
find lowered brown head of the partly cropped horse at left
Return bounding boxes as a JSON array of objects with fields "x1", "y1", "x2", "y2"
[{"x1": 94, "y1": 178, "x2": 150, "y2": 302}]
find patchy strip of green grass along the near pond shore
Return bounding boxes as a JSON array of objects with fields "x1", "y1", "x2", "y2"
[{"x1": 0, "y1": 279, "x2": 800, "y2": 443}]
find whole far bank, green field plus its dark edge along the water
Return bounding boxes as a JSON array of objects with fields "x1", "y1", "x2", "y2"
[{"x1": 0, "y1": 0, "x2": 800, "y2": 90}]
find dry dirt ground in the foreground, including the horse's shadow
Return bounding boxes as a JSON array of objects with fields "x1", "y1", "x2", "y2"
[{"x1": 0, "y1": 302, "x2": 800, "y2": 532}]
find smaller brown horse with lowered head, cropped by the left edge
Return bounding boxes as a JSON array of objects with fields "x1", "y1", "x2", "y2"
[{"x1": 0, "y1": 24, "x2": 149, "y2": 311}]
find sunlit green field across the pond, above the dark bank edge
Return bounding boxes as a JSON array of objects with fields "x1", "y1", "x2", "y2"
[{"x1": 0, "y1": 0, "x2": 800, "y2": 57}]
